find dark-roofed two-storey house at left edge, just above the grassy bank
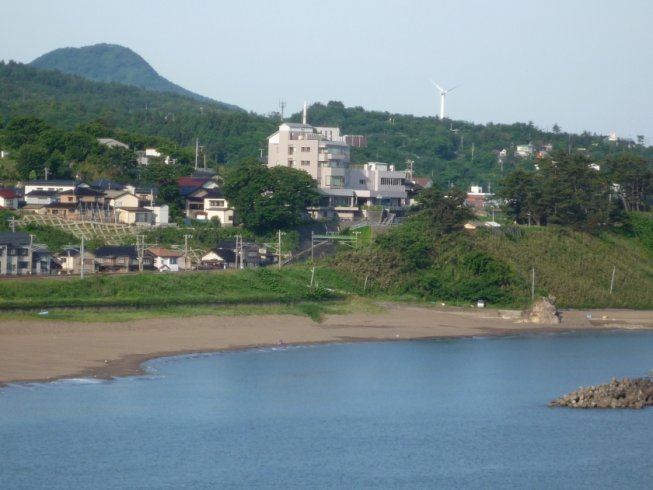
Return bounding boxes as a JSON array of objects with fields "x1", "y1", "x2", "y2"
[{"x1": 0, "y1": 231, "x2": 52, "y2": 276}]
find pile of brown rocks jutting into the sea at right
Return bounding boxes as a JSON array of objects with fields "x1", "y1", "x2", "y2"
[{"x1": 549, "y1": 378, "x2": 653, "y2": 408}]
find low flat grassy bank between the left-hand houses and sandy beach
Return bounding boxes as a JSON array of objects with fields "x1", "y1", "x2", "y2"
[{"x1": 0, "y1": 267, "x2": 340, "y2": 309}]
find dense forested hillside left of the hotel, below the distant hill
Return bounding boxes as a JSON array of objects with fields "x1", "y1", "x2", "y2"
[{"x1": 0, "y1": 61, "x2": 278, "y2": 167}]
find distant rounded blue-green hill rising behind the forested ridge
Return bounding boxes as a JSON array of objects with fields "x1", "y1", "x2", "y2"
[{"x1": 30, "y1": 44, "x2": 241, "y2": 110}]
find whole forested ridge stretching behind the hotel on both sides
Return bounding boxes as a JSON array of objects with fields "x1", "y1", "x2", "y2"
[{"x1": 0, "y1": 62, "x2": 653, "y2": 191}]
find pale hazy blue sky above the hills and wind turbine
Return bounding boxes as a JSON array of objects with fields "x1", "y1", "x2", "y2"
[{"x1": 0, "y1": 0, "x2": 653, "y2": 144}]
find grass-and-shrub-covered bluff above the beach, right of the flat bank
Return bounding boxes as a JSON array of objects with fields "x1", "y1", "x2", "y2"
[{"x1": 333, "y1": 213, "x2": 653, "y2": 309}]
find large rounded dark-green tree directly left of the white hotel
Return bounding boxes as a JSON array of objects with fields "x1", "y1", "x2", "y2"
[{"x1": 222, "y1": 159, "x2": 319, "y2": 234}]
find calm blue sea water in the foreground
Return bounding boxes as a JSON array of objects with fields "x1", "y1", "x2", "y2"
[{"x1": 0, "y1": 331, "x2": 653, "y2": 489}]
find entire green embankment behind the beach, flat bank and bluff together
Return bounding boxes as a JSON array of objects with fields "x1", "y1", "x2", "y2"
[{"x1": 0, "y1": 215, "x2": 653, "y2": 319}]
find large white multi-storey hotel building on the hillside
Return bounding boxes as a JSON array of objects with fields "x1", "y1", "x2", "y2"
[{"x1": 268, "y1": 123, "x2": 408, "y2": 219}]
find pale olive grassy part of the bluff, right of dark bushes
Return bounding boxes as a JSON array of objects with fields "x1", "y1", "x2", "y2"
[{"x1": 475, "y1": 227, "x2": 653, "y2": 309}]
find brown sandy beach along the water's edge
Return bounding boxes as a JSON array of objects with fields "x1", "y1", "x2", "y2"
[{"x1": 0, "y1": 304, "x2": 653, "y2": 386}]
